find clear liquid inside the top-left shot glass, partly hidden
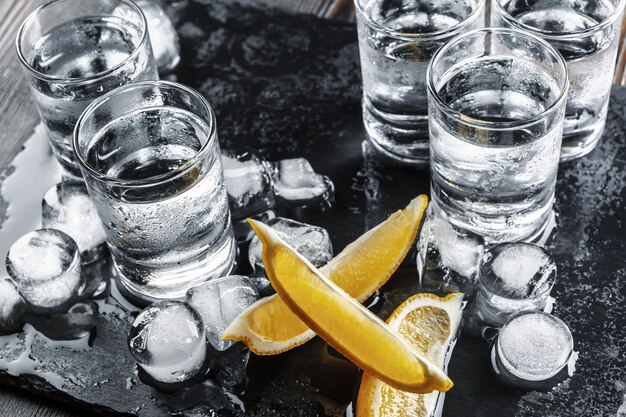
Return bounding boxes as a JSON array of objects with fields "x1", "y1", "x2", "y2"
[{"x1": 30, "y1": 16, "x2": 158, "y2": 177}]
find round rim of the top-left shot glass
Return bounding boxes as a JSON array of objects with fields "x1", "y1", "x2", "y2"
[{"x1": 15, "y1": 0, "x2": 148, "y2": 85}]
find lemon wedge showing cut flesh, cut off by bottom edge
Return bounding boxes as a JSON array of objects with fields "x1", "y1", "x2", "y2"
[{"x1": 356, "y1": 294, "x2": 463, "y2": 417}]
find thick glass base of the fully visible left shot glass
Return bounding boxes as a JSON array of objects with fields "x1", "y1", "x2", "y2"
[{"x1": 112, "y1": 233, "x2": 238, "y2": 306}]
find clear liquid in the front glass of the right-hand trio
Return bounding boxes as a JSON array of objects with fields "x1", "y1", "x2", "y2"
[{"x1": 430, "y1": 56, "x2": 562, "y2": 243}]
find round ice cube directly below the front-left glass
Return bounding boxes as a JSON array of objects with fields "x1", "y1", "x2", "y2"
[{"x1": 128, "y1": 301, "x2": 206, "y2": 383}]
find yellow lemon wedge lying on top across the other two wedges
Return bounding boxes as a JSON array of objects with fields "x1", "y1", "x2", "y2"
[{"x1": 241, "y1": 220, "x2": 452, "y2": 393}]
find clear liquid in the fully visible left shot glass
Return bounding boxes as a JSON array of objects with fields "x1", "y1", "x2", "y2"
[{"x1": 86, "y1": 106, "x2": 236, "y2": 299}]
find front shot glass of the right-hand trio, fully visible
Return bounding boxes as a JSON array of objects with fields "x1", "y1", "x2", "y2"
[{"x1": 428, "y1": 28, "x2": 568, "y2": 243}]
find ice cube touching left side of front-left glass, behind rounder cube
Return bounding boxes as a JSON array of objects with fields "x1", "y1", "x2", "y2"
[{"x1": 41, "y1": 181, "x2": 108, "y2": 263}]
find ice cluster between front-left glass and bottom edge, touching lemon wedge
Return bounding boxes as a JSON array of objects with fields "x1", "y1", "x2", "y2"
[{"x1": 128, "y1": 275, "x2": 259, "y2": 388}]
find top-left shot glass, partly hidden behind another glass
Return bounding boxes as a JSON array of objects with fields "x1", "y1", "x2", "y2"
[{"x1": 16, "y1": 0, "x2": 158, "y2": 177}]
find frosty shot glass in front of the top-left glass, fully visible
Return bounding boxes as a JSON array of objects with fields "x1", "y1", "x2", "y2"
[{"x1": 74, "y1": 81, "x2": 236, "y2": 304}]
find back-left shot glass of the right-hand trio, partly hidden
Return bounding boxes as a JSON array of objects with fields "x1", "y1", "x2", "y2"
[{"x1": 354, "y1": 0, "x2": 485, "y2": 168}]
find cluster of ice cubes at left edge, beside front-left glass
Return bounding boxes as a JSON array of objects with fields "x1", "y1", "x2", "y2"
[{"x1": 0, "y1": 180, "x2": 110, "y2": 332}]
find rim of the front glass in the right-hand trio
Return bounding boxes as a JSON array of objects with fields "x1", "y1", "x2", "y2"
[{"x1": 426, "y1": 27, "x2": 569, "y2": 131}]
